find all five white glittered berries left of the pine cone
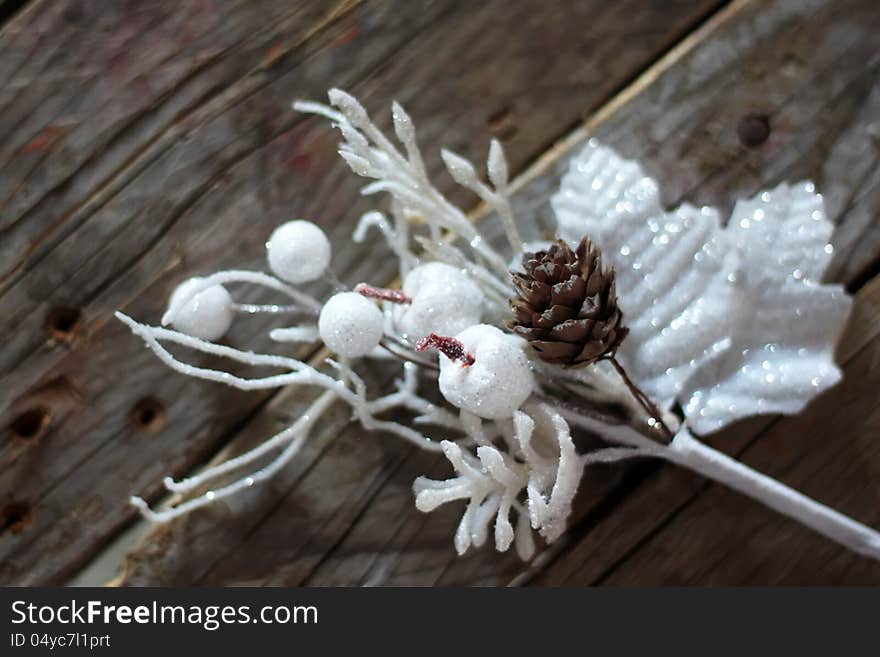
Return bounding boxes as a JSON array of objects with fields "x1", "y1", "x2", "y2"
[{"x1": 169, "y1": 219, "x2": 535, "y2": 420}]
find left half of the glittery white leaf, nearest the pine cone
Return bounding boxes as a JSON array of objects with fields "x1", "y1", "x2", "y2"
[{"x1": 552, "y1": 140, "x2": 737, "y2": 408}]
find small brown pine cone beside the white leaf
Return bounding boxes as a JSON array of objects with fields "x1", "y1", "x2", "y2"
[{"x1": 510, "y1": 237, "x2": 629, "y2": 367}]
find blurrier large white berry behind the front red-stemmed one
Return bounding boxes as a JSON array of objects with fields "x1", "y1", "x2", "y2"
[{"x1": 394, "y1": 262, "x2": 485, "y2": 340}]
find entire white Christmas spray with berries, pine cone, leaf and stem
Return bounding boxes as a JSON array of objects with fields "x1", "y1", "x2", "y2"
[{"x1": 117, "y1": 90, "x2": 880, "y2": 559}]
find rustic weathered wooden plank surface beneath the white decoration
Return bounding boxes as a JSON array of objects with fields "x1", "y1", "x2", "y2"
[{"x1": 0, "y1": 0, "x2": 880, "y2": 585}]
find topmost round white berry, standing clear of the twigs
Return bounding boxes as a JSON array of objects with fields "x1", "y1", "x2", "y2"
[{"x1": 266, "y1": 219, "x2": 330, "y2": 283}]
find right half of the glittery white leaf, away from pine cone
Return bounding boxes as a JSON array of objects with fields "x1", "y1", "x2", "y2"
[{"x1": 681, "y1": 183, "x2": 851, "y2": 433}]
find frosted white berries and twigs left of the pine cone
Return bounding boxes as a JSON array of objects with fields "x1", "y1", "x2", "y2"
[{"x1": 117, "y1": 90, "x2": 596, "y2": 559}]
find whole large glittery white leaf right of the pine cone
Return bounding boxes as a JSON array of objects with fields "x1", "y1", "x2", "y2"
[{"x1": 552, "y1": 140, "x2": 850, "y2": 433}]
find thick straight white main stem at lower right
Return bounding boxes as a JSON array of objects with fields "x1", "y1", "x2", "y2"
[{"x1": 658, "y1": 428, "x2": 880, "y2": 559}]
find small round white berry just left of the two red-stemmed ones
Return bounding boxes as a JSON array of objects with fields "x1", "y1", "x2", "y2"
[{"x1": 318, "y1": 292, "x2": 384, "y2": 358}]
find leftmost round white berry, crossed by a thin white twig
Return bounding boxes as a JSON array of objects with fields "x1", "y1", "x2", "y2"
[{"x1": 168, "y1": 277, "x2": 235, "y2": 342}]
